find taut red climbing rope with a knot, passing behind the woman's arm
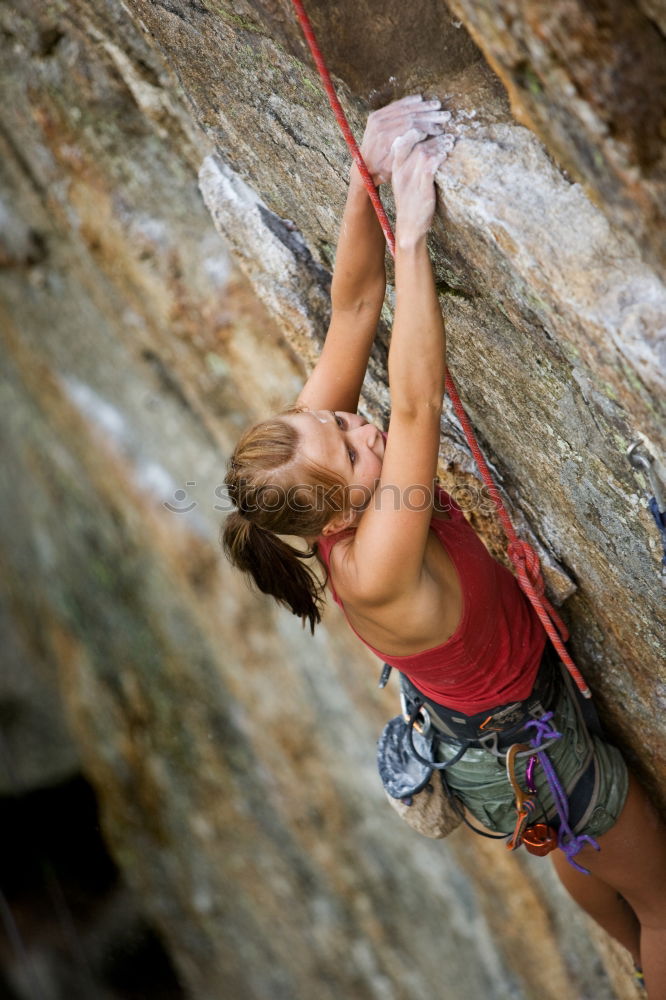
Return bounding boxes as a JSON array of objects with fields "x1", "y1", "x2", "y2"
[{"x1": 292, "y1": 0, "x2": 591, "y2": 698}]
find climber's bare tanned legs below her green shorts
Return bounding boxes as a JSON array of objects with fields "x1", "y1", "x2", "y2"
[{"x1": 556, "y1": 773, "x2": 666, "y2": 1000}]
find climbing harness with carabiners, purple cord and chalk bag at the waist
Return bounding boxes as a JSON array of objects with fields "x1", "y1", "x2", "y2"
[{"x1": 377, "y1": 647, "x2": 599, "y2": 873}]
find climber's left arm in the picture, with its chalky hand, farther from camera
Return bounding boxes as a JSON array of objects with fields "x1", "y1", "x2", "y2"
[{"x1": 297, "y1": 95, "x2": 449, "y2": 413}]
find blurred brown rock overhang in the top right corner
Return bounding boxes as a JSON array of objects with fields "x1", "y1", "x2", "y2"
[{"x1": 450, "y1": 0, "x2": 666, "y2": 277}]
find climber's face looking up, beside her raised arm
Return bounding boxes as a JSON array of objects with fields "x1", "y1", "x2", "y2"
[{"x1": 283, "y1": 410, "x2": 385, "y2": 524}]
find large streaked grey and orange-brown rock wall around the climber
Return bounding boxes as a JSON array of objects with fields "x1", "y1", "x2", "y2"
[{"x1": 0, "y1": 0, "x2": 666, "y2": 1000}]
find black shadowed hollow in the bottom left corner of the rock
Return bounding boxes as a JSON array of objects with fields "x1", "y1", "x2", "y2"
[{"x1": 0, "y1": 776, "x2": 185, "y2": 1000}]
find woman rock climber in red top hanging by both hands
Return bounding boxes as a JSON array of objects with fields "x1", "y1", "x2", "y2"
[{"x1": 223, "y1": 96, "x2": 666, "y2": 1000}]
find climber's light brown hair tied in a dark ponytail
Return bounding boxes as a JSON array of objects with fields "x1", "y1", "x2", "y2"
[{"x1": 221, "y1": 406, "x2": 347, "y2": 635}]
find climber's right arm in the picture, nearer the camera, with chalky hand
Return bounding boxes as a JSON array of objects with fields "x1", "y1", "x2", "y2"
[{"x1": 345, "y1": 136, "x2": 446, "y2": 604}]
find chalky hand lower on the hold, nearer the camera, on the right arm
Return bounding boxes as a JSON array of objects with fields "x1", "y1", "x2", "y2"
[{"x1": 392, "y1": 130, "x2": 452, "y2": 246}]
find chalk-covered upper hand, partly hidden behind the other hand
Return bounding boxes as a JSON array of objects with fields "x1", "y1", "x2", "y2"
[{"x1": 361, "y1": 94, "x2": 451, "y2": 185}]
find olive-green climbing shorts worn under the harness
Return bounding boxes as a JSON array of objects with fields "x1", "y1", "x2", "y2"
[{"x1": 437, "y1": 668, "x2": 629, "y2": 837}]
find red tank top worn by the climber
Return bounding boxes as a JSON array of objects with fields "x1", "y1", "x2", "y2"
[{"x1": 318, "y1": 474, "x2": 546, "y2": 715}]
